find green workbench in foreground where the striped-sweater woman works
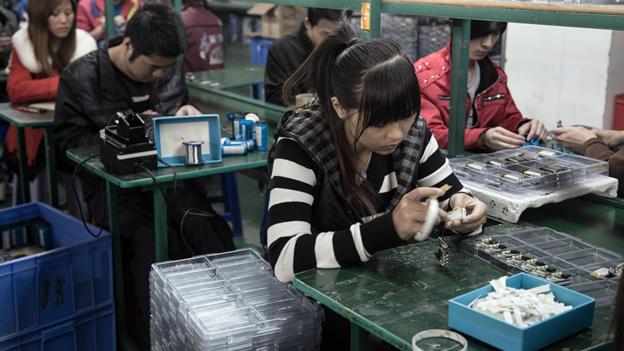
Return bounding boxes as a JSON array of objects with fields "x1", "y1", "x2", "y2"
[{"x1": 293, "y1": 224, "x2": 615, "y2": 351}]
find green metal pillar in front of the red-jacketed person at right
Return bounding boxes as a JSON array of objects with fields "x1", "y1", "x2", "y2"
[{"x1": 448, "y1": 19, "x2": 470, "y2": 157}]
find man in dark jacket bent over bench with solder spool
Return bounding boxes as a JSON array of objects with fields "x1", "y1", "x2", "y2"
[{"x1": 54, "y1": 4, "x2": 234, "y2": 346}]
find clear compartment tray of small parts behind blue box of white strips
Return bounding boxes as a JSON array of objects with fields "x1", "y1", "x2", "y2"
[{"x1": 461, "y1": 228, "x2": 624, "y2": 307}]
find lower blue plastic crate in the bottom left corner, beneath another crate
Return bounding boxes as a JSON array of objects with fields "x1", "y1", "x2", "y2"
[{"x1": 0, "y1": 303, "x2": 115, "y2": 351}]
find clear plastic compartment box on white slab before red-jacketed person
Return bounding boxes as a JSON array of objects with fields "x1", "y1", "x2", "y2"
[{"x1": 450, "y1": 146, "x2": 609, "y2": 194}]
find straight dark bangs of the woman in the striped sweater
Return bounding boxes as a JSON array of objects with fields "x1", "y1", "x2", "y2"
[{"x1": 359, "y1": 55, "x2": 420, "y2": 130}]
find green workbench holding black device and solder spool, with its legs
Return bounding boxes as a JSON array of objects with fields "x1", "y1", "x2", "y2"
[{"x1": 66, "y1": 145, "x2": 267, "y2": 346}]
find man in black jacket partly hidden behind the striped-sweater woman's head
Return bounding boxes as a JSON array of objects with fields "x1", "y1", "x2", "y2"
[{"x1": 264, "y1": 8, "x2": 351, "y2": 105}]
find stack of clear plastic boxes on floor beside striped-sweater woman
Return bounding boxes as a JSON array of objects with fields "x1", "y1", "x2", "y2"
[{"x1": 150, "y1": 249, "x2": 323, "y2": 351}]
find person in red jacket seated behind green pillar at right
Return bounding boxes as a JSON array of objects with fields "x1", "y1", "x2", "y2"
[{"x1": 414, "y1": 21, "x2": 546, "y2": 151}]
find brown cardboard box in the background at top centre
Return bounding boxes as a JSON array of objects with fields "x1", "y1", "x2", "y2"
[{"x1": 247, "y1": 3, "x2": 308, "y2": 39}]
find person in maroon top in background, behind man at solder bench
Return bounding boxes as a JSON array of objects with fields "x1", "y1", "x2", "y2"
[{"x1": 182, "y1": 0, "x2": 223, "y2": 72}]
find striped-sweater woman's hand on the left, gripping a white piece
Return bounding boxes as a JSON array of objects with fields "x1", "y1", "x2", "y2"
[{"x1": 392, "y1": 187, "x2": 444, "y2": 240}]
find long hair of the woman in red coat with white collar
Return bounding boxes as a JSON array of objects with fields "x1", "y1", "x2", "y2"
[{"x1": 28, "y1": 0, "x2": 77, "y2": 76}]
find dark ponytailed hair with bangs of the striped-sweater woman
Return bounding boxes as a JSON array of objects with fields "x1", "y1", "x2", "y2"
[{"x1": 282, "y1": 19, "x2": 420, "y2": 214}]
